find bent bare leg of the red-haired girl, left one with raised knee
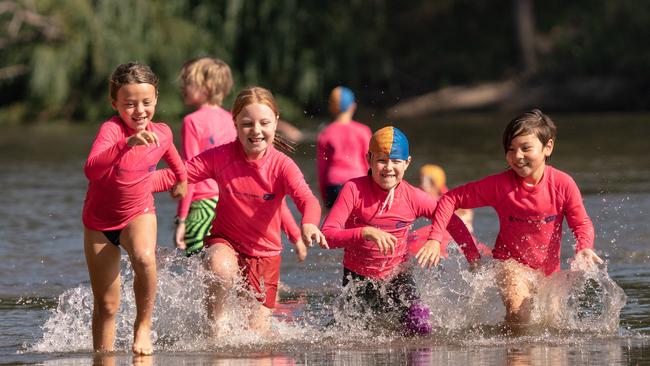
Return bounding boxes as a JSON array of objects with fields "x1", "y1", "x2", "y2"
[{"x1": 206, "y1": 244, "x2": 239, "y2": 332}]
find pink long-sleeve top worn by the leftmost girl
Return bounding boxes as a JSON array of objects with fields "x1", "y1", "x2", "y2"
[{"x1": 82, "y1": 116, "x2": 187, "y2": 231}]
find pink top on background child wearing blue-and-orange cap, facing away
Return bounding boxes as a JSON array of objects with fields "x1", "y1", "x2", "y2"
[{"x1": 316, "y1": 121, "x2": 372, "y2": 199}]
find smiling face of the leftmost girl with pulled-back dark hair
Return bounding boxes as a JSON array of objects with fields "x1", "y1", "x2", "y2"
[{"x1": 112, "y1": 83, "x2": 158, "y2": 130}]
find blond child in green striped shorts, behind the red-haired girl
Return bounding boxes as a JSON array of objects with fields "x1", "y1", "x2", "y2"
[{"x1": 174, "y1": 57, "x2": 306, "y2": 259}]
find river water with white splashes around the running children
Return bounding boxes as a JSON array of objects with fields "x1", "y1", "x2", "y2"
[{"x1": 0, "y1": 114, "x2": 650, "y2": 365}]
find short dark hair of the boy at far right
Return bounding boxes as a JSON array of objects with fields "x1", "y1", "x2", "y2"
[{"x1": 503, "y1": 108, "x2": 557, "y2": 153}]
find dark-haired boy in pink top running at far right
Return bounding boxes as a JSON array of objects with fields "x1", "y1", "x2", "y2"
[{"x1": 420, "y1": 109, "x2": 602, "y2": 331}]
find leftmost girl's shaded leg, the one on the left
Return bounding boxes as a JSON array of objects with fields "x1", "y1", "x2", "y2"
[{"x1": 84, "y1": 227, "x2": 120, "y2": 352}]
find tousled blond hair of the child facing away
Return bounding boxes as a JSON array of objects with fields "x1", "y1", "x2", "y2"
[{"x1": 180, "y1": 57, "x2": 233, "y2": 105}]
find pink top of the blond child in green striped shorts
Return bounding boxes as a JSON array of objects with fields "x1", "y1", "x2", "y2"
[{"x1": 176, "y1": 106, "x2": 237, "y2": 219}]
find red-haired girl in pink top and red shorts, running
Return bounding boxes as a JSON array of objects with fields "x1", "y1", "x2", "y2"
[{"x1": 154, "y1": 87, "x2": 327, "y2": 332}]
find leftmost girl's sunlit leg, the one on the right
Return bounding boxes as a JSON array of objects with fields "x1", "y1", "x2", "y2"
[{"x1": 120, "y1": 214, "x2": 157, "y2": 355}]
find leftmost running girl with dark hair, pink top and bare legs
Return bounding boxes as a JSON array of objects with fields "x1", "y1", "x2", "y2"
[{"x1": 83, "y1": 63, "x2": 187, "y2": 354}]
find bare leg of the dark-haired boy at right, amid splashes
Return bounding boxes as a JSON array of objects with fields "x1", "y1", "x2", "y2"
[{"x1": 497, "y1": 263, "x2": 533, "y2": 331}]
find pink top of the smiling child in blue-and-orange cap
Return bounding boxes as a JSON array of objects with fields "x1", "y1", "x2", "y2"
[{"x1": 323, "y1": 176, "x2": 480, "y2": 279}]
